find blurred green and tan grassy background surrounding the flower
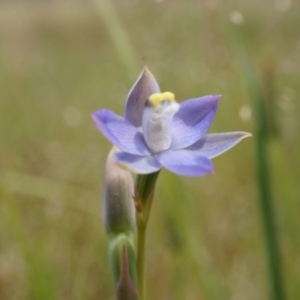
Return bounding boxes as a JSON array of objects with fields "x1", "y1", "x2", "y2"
[{"x1": 0, "y1": 0, "x2": 300, "y2": 300}]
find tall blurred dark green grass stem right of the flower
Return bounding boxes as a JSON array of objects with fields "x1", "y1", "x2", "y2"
[{"x1": 234, "y1": 26, "x2": 285, "y2": 300}]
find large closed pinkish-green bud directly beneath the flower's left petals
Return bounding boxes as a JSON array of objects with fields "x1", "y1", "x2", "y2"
[{"x1": 103, "y1": 147, "x2": 135, "y2": 234}]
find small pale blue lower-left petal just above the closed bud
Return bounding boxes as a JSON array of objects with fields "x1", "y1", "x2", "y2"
[{"x1": 116, "y1": 152, "x2": 161, "y2": 174}]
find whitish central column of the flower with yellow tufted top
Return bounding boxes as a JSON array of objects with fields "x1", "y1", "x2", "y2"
[{"x1": 142, "y1": 92, "x2": 179, "y2": 152}]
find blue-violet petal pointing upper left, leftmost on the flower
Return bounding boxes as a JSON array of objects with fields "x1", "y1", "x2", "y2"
[{"x1": 92, "y1": 109, "x2": 150, "y2": 155}]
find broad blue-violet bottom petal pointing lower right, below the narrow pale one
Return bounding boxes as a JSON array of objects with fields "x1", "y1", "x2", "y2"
[{"x1": 155, "y1": 150, "x2": 213, "y2": 176}]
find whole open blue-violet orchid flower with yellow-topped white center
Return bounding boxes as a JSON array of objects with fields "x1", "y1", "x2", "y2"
[{"x1": 92, "y1": 67, "x2": 251, "y2": 176}]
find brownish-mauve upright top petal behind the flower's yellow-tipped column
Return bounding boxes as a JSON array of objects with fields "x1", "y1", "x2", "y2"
[{"x1": 125, "y1": 67, "x2": 160, "y2": 127}]
